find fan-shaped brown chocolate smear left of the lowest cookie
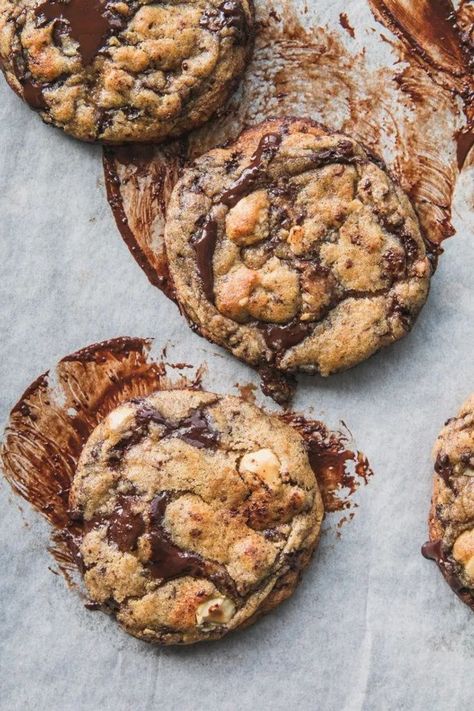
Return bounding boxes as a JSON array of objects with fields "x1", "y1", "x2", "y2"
[{"x1": 0, "y1": 338, "x2": 207, "y2": 582}]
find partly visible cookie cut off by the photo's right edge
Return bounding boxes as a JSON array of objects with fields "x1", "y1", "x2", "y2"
[{"x1": 423, "y1": 395, "x2": 474, "y2": 610}]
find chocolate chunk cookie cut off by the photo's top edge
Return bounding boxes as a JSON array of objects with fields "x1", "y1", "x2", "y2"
[{"x1": 0, "y1": 0, "x2": 254, "y2": 143}]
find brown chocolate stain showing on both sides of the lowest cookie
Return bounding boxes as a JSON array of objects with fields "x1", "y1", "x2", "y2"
[{"x1": 1, "y1": 338, "x2": 372, "y2": 584}]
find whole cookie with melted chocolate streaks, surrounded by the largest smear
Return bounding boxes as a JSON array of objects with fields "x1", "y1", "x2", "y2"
[{"x1": 165, "y1": 119, "x2": 431, "y2": 375}]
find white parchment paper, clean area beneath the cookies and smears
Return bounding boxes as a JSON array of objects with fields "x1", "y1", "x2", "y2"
[{"x1": 0, "y1": 1, "x2": 474, "y2": 711}]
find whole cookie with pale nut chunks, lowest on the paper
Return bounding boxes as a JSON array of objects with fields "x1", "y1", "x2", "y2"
[{"x1": 70, "y1": 390, "x2": 324, "y2": 644}]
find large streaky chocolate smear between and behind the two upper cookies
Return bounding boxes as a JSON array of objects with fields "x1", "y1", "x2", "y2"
[{"x1": 105, "y1": 0, "x2": 474, "y2": 288}]
